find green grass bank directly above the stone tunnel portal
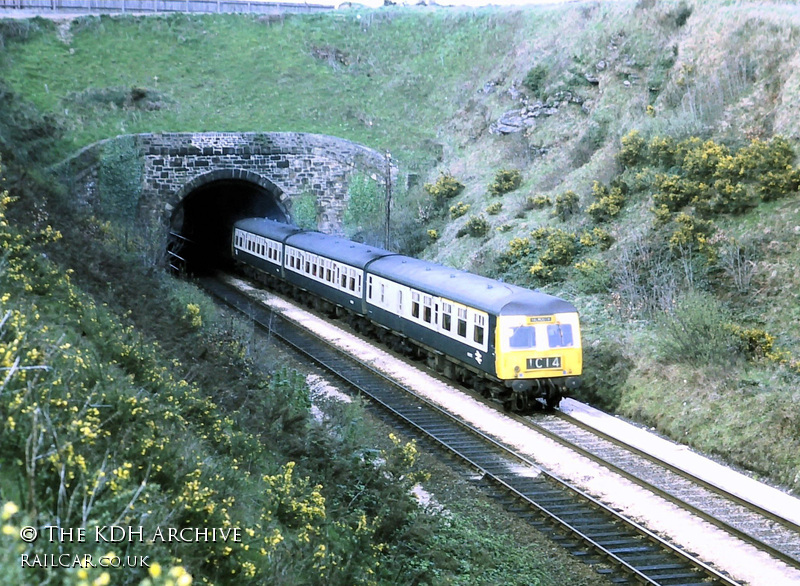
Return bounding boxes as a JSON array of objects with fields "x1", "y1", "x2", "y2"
[{"x1": 2, "y1": 10, "x2": 513, "y2": 167}]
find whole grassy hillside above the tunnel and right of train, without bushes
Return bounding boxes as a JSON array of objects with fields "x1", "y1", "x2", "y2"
[{"x1": 3, "y1": 2, "x2": 800, "y2": 485}]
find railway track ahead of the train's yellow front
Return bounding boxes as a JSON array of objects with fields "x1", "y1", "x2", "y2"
[{"x1": 523, "y1": 406, "x2": 800, "y2": 569}]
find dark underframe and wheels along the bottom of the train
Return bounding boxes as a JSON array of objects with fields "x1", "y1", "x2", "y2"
[{"x1": 237, "y1": 264, "x2": 566, "y2": 414}]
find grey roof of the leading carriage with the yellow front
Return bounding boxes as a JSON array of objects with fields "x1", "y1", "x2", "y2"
[{"x1": 367, "y1": 255, "x2": 577, "y2": 315}]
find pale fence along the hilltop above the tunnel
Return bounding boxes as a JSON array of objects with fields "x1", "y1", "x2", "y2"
[{"x1": 0, "y1": 0, "x2": 334, "y2": 17}]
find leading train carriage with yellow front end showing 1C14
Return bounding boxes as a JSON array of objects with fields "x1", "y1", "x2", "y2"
[{"x1": 367, "y1": 255, "x2": 582, "y2": 402}]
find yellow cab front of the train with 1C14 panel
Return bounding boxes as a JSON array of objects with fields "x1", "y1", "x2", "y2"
[{"x1": 495, "y1": 312, "x2": 583, "y2": 392}]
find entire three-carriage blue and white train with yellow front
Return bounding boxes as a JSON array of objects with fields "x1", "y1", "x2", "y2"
[{"x1": 231, "y1": 218, "x2": 582, "y2": 412}]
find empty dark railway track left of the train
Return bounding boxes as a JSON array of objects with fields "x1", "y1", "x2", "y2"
[{"x1": 201, "y1": 279, "x2": 738, "y2": 586}]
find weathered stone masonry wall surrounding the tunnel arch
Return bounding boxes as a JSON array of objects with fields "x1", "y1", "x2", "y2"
[{"x1": 58, "y1": 132, "x2": 395, "y2": 233}]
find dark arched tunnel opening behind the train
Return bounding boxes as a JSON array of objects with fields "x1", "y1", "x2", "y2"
[{"x1": 167, "y1": 179, "x2": 288, "y2": 275}]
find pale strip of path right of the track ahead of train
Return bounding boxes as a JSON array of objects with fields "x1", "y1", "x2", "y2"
[{"x1": 559, "y1": 399, "x2": 800, "y2": 525}]
